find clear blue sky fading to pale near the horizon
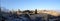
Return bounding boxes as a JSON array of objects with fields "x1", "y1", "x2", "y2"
[{"x1": 0, "y1": 0, "x2": 60, "y2": 10}]
